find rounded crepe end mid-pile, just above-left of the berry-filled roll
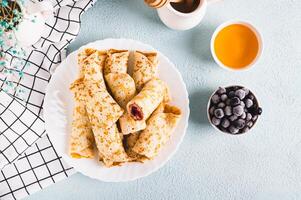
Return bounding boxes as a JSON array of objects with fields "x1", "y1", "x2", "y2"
[{"x1": 105, "y1": 73, "x2": 136, "y2": 109}]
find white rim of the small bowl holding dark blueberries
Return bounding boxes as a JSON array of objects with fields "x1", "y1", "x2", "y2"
[{"x1": 207, "y1": 85, "x2": 260, "y2": 135}]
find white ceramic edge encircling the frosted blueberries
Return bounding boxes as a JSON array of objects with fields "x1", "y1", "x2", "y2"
[{"x1": 207, "y1": 85, "x2": 260, "y2": 136}]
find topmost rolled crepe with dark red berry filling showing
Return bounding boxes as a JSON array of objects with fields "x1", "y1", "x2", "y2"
[{"x1": 127, "y1": 78, "x2": 169, "y2": 121}]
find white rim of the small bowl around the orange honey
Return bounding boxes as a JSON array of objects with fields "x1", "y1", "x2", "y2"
[{"x1": 210, "y1": 20, "x2": 263, "y2": 71}]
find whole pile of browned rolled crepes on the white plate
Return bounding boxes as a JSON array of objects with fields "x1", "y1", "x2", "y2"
[{"x1": 69, "y1": 49, "x2": 181, "y2": 167}]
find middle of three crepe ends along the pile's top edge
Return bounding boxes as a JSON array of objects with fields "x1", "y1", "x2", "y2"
[{"x1": 104, "y1": 49, "x2": 130, "y2": 75}]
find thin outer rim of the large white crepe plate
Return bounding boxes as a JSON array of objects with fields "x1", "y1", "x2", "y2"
[{"x1": 44, "y1": 38, "x2": 190, "y2": 182}]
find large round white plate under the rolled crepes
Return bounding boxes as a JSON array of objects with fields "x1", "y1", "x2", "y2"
[{"x1": 44, "y1": 39, "x2": 189, "y2": 182}]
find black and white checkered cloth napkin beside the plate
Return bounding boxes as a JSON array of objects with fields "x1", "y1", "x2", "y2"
[{"x1": 0, "y1": 0, "x2": 95, "y2": 200}]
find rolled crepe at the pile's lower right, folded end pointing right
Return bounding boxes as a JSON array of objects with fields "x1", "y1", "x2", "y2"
[{"x1": 132, "y1": 105, "x2": 181, "y2": 159}]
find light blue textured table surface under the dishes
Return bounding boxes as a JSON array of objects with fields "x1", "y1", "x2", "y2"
[{"x1": 27, "y1": 0, "x2": 301, "y2": 200}]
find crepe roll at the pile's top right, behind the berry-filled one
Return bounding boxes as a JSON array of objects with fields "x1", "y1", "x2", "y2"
[{"x1": 133, "y1": 51, "x2": 158, "y2": 91}]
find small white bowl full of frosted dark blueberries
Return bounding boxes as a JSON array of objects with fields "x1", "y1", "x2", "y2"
[{"x1": 207, "y1": 86, "x2": 262, "y2": 135}]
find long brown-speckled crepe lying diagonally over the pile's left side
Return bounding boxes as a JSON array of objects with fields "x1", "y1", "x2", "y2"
[{"x1": 71, "y1": 51, "x2": 129, "y2": 167}]
